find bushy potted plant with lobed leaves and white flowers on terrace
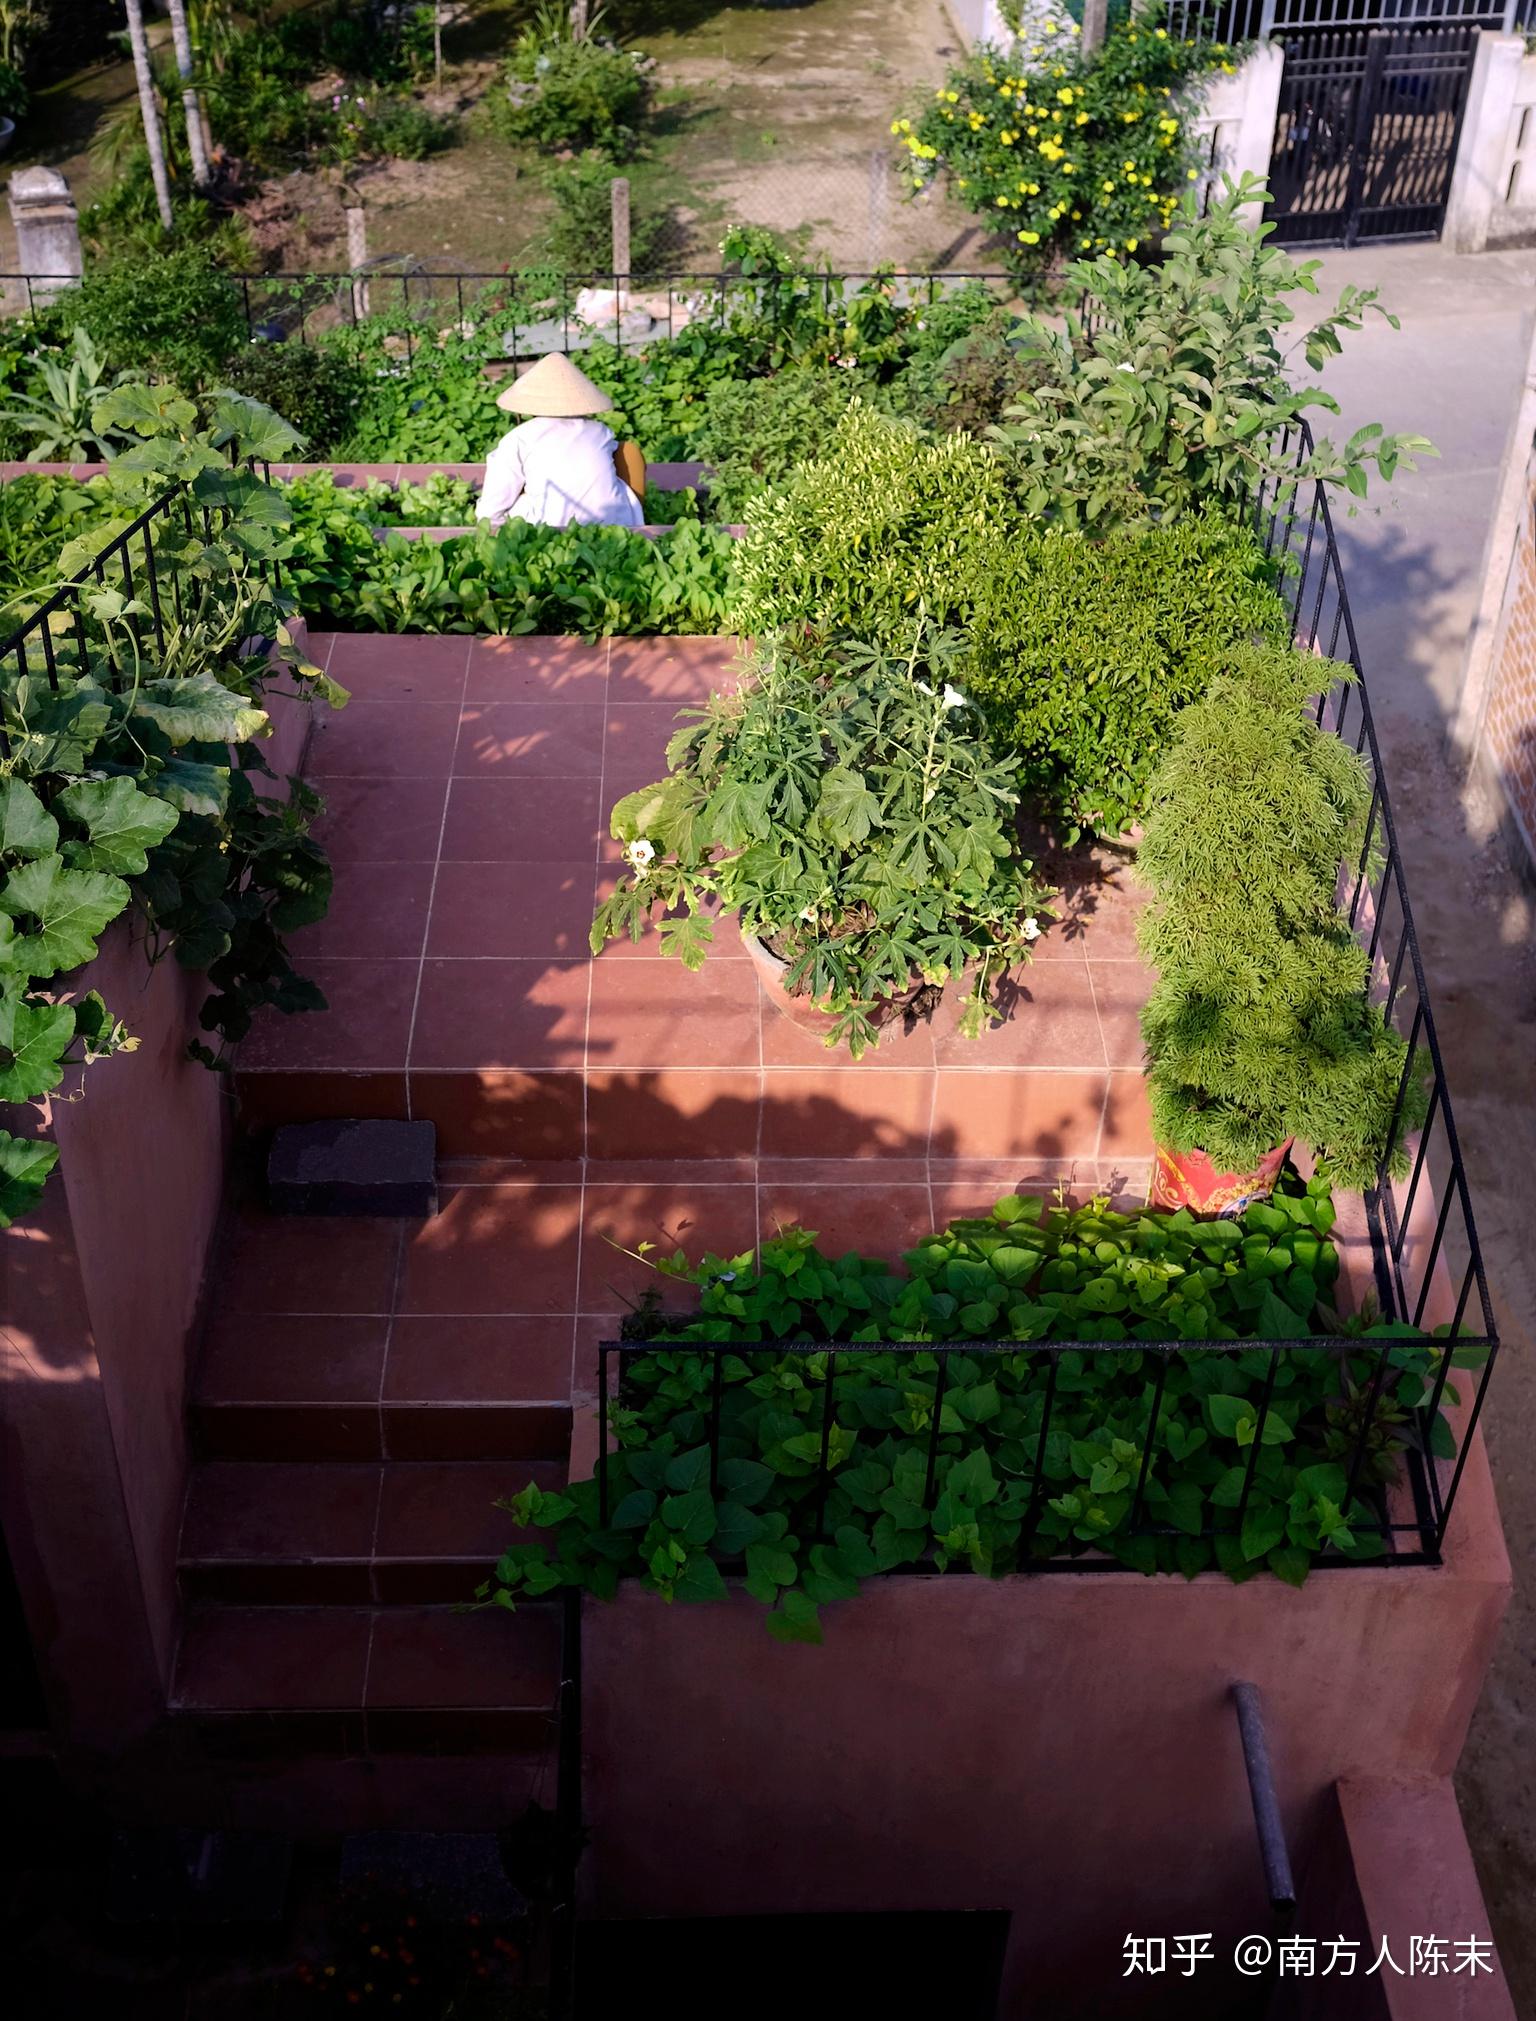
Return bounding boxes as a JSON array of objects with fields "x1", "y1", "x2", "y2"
[{"x1": 592, "y1": 620, "x2": 1049, "y2": 1059}]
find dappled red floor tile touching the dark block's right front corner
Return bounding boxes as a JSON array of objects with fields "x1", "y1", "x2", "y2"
[{"x1": 400, "y1": 1186, "x2": 582, "y2": 1314}]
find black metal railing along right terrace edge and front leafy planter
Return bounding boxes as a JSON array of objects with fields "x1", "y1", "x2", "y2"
[{"x1": 598, "y1": 422, "x2": 1498, "y2": 1570}]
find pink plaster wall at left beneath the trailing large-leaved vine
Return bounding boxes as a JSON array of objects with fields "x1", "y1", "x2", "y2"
[{"x1": 0, "y1": 650, "x2": 309, "y2": 1748}]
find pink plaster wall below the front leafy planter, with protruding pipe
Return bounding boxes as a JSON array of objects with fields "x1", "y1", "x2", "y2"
[{"x1": 584, "y1": 1449, "x2": 1508, "y2": 2021}]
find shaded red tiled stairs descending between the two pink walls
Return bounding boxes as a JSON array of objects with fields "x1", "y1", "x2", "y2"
[{"x1": 172, "y1": 1209, "x2": 572, "y2": 1774}]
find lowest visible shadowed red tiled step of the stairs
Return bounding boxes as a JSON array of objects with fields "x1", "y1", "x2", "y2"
[{"x1": 172, "y1": 1603, "x2": 560, "y2": 1756}]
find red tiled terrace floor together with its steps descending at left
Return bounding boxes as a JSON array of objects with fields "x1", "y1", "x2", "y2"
[{"x1": 164, "y1": 635, "x2": 1150, "y2": 1801}]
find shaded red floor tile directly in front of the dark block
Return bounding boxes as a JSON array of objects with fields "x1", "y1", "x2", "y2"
[{"x1": 218, "y1": 1211, "x2": 402, "y2": 1332}]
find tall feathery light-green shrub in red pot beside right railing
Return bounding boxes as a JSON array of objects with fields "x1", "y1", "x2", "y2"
[{"x1": 1136, "y1": 645, "x2": 1423, "y2": 1213}]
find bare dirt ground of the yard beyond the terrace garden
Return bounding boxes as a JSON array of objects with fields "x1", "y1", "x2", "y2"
[{"x1": 0, "y1": 0, "x2": 988, "y2": 273}]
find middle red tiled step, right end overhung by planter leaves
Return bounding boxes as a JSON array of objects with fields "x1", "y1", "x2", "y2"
[{"x1": 178, "y1": 1459, "x2": 566, "y2": 1607}]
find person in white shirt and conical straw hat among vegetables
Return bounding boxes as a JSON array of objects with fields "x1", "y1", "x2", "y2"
[{"x1": 475, "y1": 352, "x2": 645, "y2": 525}]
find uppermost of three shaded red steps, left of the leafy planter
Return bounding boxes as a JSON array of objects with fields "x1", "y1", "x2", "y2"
[{"x1": 192, "y1": 1301, "x2": 572, "y2": 1461}]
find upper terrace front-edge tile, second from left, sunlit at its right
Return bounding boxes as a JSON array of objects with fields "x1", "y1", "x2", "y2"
[{"x1": 410, "y1": 960, "x2": 590, "y2": 1071}]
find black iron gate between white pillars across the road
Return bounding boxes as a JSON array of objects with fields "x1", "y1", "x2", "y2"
[{"x1": 1267, "y1": 28, "x2": 1477, "y2": 245}]
